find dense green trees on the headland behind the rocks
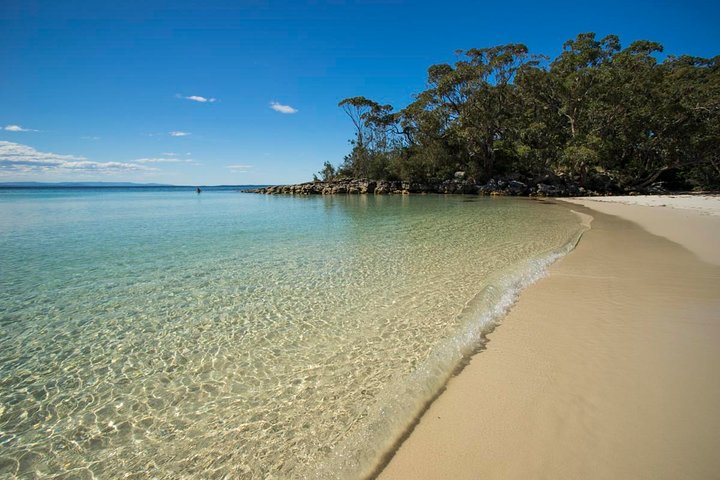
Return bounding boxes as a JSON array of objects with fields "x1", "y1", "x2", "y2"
[{"x1": 320, "y1": 33, "x2": 720, "y2": 189}]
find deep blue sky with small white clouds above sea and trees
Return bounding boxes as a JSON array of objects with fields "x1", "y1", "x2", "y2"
[{"x1": 0, "y1": 0, "x2": 720, "y2": 185}]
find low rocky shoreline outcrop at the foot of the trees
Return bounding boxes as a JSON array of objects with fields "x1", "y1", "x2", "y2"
[{"x1": 246, "y1": 172, "x2": 664, "y2": 197}]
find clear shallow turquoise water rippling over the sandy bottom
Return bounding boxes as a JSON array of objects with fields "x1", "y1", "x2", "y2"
[{"x1": 0, "y1": 189, "x2": 582, "y2": 478}]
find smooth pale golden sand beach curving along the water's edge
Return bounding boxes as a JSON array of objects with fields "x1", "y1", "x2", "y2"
[{"x1": 379, "y1": 196, "x2": 720, "y2": 479}]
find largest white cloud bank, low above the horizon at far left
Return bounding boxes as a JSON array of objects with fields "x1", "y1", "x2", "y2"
[{"x1": 0, "y1": 141, "x2": 155, "y2": 174}]
